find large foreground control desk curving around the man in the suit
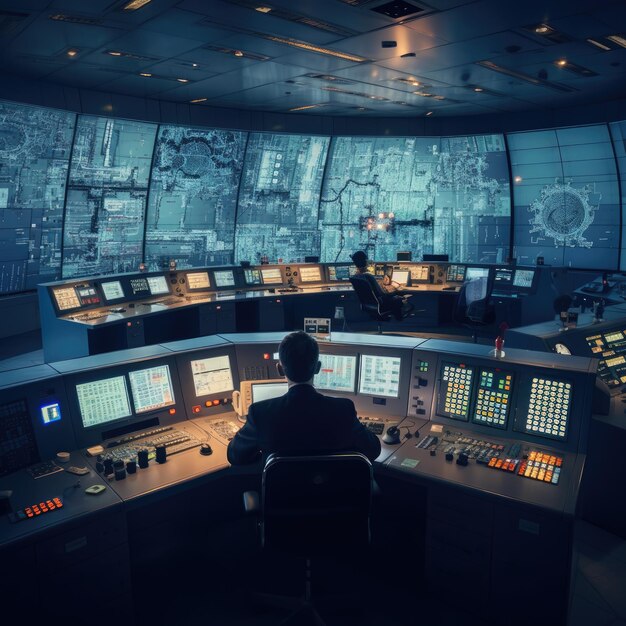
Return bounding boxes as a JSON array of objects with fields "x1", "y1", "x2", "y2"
[{"x1": 0, "y1": 332, "x2": 596, "y2": 624}]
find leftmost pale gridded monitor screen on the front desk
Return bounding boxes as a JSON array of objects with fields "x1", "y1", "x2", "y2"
[{"x1": 76, "y1": 376, "x2": 131, "y2": 428}]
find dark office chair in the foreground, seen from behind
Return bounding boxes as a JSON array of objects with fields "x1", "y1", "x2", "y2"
[{"x1": 243, "y1": 453, "x2": 373, "y2": 626}]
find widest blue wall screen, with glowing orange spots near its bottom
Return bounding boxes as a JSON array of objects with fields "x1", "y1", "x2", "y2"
[{"x1": 320, "y1": 135, "x2": 511, "y2": 263}]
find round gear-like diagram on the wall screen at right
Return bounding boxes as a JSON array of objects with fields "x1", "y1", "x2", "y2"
[{"x1": 529, "y1": 182, "x2": 600, "y2": 248}]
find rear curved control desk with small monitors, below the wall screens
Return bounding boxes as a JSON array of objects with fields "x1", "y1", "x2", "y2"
[{"x1": 38, "y1": 262, "x2": 561, "y2": 362}]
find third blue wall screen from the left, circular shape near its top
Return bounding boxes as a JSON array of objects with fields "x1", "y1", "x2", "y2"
[{"x1": 145, "y1": 126, "x2": 247, "y2": 270}]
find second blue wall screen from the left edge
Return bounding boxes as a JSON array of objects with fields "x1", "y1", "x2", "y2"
[{"x1": 63, "y1": 116, "x2": 157, "y2": 278}]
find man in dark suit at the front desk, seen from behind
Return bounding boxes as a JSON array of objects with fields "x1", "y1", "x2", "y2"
[{"x1": 228, "y1": 331, "x2": 380, "y2": 465}]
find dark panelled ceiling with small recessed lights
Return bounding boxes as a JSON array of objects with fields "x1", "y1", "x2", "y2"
[{"x1": 0, "y1": 0, "x2": 626, "y2": 117}]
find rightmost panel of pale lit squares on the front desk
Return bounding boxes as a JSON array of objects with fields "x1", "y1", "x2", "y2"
[{"x1": 524, "y1": 377, "x2": 572, "y2": 440}]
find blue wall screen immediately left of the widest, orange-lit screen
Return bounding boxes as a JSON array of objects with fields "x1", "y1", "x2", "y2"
[{"x1": 235, "y1": 133, "x2": 330, "y2": 263}]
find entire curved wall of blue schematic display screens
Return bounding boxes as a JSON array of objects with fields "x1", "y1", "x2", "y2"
[{"x1": 0, "y1": 97, "x2": 626, "y2": 294}]
